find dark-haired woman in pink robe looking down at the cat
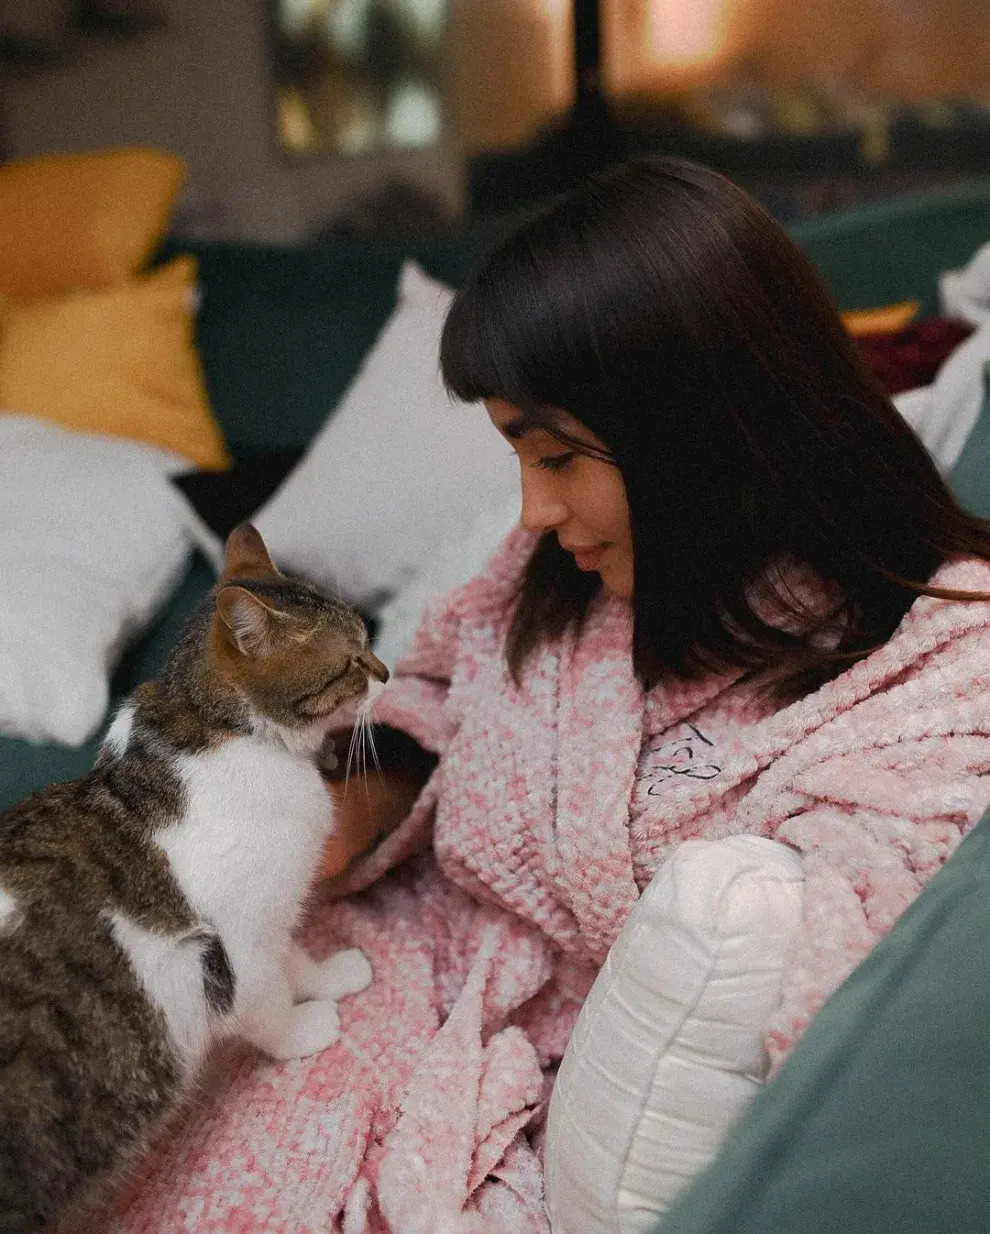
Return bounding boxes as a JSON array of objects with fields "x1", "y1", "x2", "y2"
[{"x1": 119, "y1": 160, "x2": 990, "y2": 1234}]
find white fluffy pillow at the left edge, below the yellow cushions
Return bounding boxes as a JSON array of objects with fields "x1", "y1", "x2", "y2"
[{"x1": 0, "y1": 415, "x2": 191, "y2": 745}]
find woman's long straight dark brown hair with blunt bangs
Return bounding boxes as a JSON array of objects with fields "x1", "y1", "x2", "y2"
[{"x1": 441, "y1": 158, "x2": 990, "y2": 697}]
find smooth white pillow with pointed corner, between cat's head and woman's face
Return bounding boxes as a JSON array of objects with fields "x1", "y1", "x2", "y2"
[{"x1": 253, "y1": 262, "x2": 518, "y2": 611}]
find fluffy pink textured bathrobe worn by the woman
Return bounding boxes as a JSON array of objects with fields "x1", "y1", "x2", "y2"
[{"x1": 98, "y1": 533, "x2": 990, "y2": 1234}]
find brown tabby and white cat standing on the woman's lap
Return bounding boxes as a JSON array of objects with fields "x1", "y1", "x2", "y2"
[{"x1": 0, "y1": 524, "x2": 388, "y2": 1234}]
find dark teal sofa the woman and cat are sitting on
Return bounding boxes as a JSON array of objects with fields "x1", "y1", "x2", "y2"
[{"x1": 0, "y1": 173, "x2": 990, "y2": 1234}]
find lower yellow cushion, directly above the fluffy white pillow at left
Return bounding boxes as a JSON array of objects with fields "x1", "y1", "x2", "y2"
[{"x1": 0, "y1": 257, "x2": 231, "y2": 470}]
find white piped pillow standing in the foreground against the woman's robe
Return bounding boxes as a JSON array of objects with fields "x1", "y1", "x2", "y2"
[{"x1": 546, "y1": 835, "x2": 804, "y2": 1234}]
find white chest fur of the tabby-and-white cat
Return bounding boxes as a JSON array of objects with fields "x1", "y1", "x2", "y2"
[{"x1": 156, "y1": 737, "x2": 332, "y2": 976}]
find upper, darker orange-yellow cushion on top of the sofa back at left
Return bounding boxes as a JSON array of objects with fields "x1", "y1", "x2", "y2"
[{"x1": 0, "y1": 149, "x2": 185, "y2": 296}]
